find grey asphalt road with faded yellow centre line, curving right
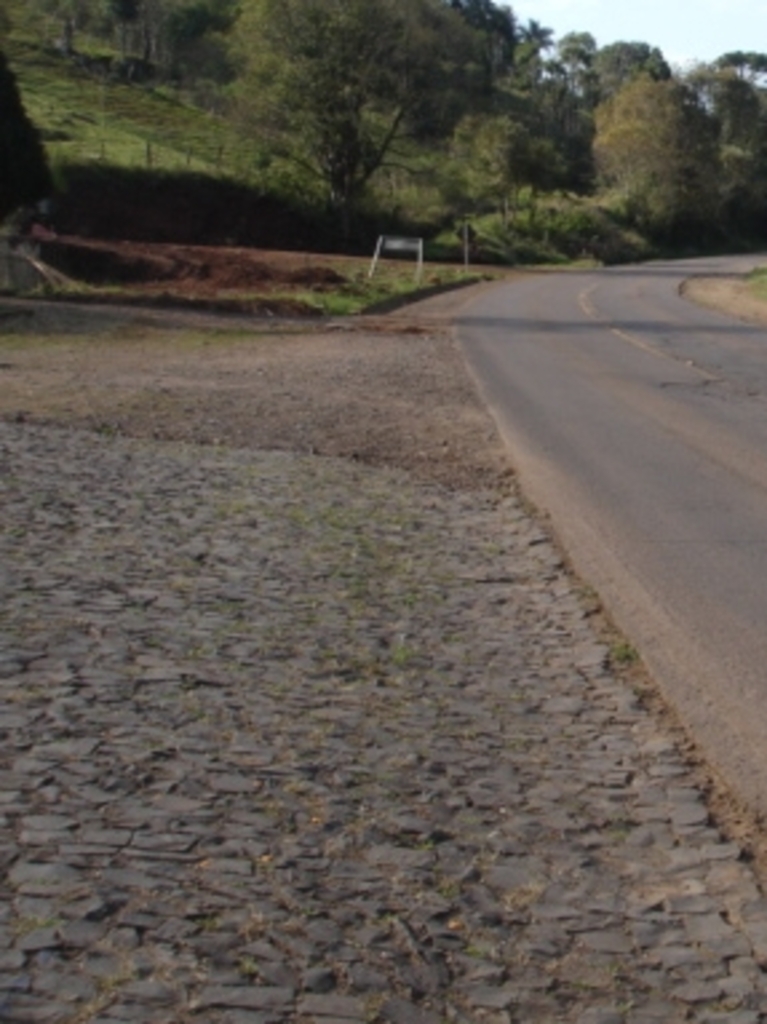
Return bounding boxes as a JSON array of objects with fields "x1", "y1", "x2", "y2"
[{"x1": 458, "y1": 257, "x2": 767, "y2": 813}]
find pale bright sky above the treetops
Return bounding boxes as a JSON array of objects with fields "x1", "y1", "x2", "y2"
[{"x1": 507, "y1": 0, "x2": 767, "y2": 68}]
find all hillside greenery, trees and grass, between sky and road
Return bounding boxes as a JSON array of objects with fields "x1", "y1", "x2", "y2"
[{"x1": 0, "y1": 0, "x2": 767, "y2": 265}]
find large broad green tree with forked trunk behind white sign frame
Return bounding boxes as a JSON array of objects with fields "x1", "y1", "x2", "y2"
[{"x1": 238, "y1": 0, "x2": 473, "y2": 234}]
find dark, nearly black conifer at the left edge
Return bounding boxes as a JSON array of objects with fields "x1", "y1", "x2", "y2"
[{"x1": 0, "y1": 52, "x2": 53, "y2": 221}]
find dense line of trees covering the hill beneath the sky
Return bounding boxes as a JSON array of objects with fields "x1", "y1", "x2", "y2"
[{"x1": 10, "y1": 0, "x2": 767, "y2": 253}]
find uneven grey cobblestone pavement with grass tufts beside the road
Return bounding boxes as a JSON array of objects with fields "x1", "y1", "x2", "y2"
[{"x1": 0, "y1": 423, "x2": 767, "y2": 1024}]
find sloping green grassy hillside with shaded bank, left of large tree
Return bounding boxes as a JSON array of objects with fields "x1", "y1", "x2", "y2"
[{"x1": 2, "y1": 0, "x2": 334, "y2": 249}]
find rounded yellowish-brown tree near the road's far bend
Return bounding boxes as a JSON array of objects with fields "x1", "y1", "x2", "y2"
[{"x1": 595, "y1": 77, "x2": 720, "y2": 241}]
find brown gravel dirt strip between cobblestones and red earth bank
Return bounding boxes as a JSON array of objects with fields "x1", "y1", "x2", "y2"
[{"x1": 0, "y1": 286, "x2": 509, "y2": 488}]
